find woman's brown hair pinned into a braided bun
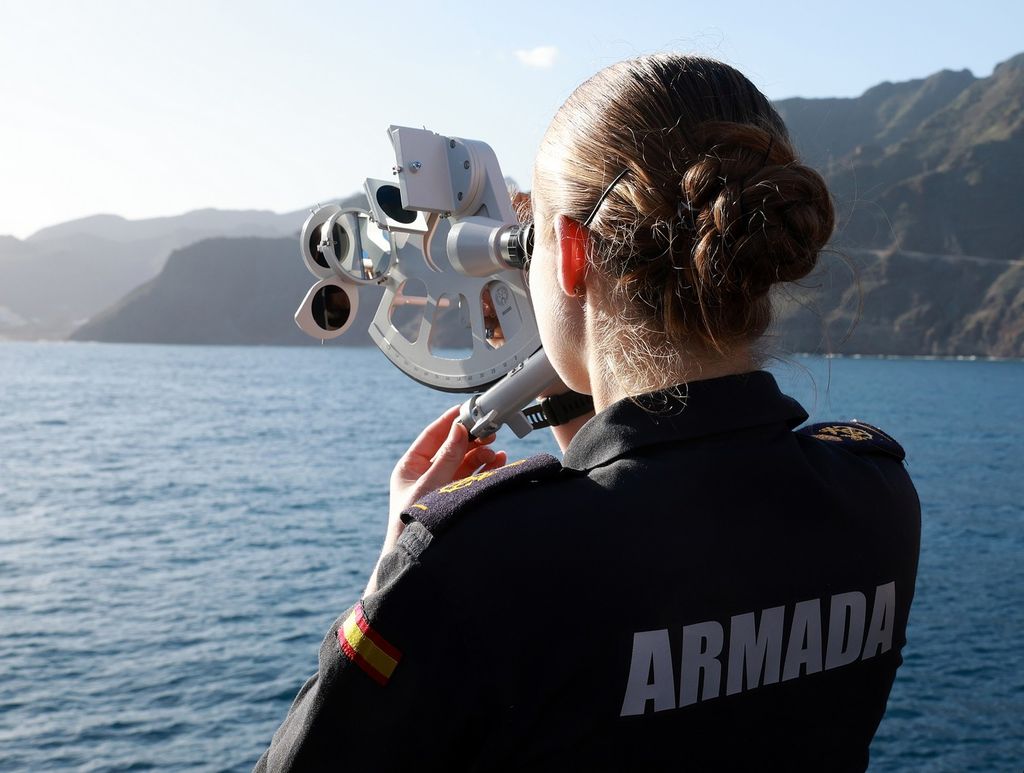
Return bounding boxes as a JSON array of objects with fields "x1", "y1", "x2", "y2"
[{"x1": 532, "y1": 55, "x2": 835, "y2": 399}]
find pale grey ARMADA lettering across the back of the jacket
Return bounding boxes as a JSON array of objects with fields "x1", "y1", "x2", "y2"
[{"x1": 620, "y1": 583, "x2": 896, "y2": 717}]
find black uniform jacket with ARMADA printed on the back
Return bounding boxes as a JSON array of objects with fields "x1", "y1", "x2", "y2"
[{"x1": 257, "y1": 372, "x2": 921, "y2": 771}]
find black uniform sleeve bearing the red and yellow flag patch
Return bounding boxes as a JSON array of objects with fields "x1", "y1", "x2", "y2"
[{"x1": 255, "y1": 523, "x2": 483, "y2": 773}]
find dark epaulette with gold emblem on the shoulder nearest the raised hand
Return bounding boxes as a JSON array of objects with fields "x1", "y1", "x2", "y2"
[{"x1": 401, "y1": 454, "x2": 562, "y2": 534}]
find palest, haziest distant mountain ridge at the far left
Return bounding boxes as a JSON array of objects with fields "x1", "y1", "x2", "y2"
[{"x1": 0, "y1": 196, "x2": 364, "y2": 339}]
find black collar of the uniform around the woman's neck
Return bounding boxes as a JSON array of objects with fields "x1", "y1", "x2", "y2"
[{"x1": 562, "y1": 371, "x2": 807, "y2": 471}]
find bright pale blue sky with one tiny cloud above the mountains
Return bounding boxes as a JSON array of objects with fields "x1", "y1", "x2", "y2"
[{"x1": 0, "y1": 0, "x2": 1024, "y2": 239}]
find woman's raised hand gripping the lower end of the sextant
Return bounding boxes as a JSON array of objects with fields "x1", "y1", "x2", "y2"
[{"x1": 384, "y1": 405, "x2": 507, "y2": 553}]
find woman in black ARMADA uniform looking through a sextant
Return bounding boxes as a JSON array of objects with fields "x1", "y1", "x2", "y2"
[{"x1": 257, "y1": 55, "x2": 920, "y2": 771}]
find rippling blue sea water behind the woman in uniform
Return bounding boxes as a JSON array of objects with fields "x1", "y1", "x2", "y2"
[{"x1": 0, "y1": 343, "x2": 1024, "y2": 771}]
